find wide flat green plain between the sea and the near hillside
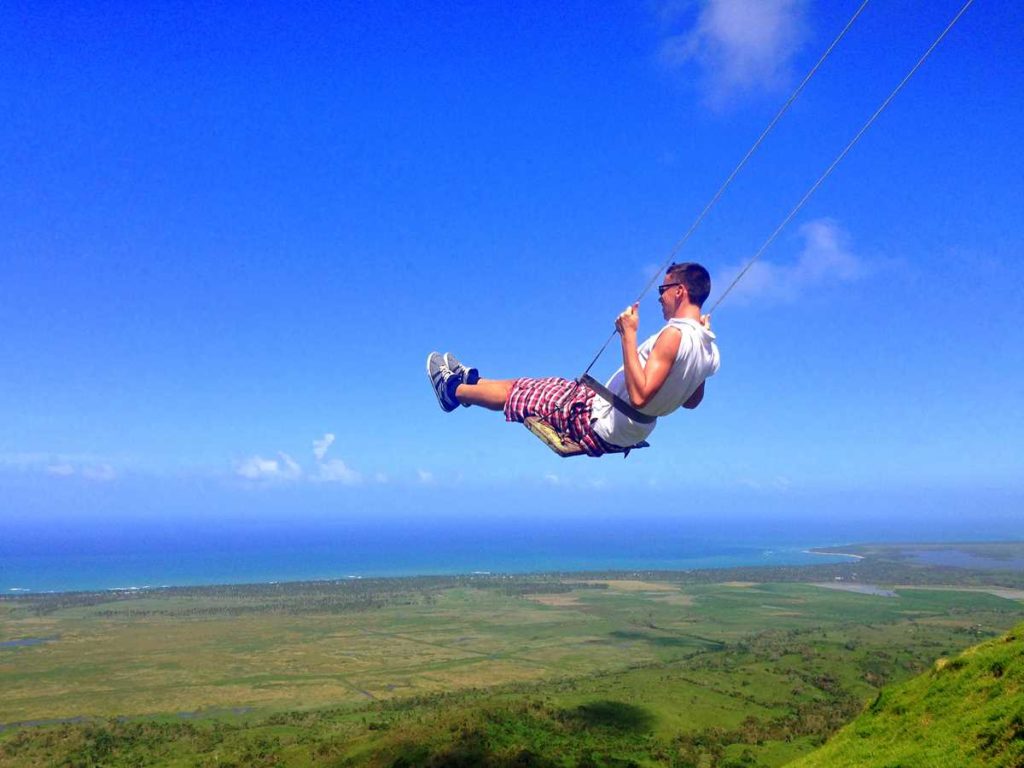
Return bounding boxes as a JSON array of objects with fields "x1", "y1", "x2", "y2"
[{"x1": 0, "y1": 561, "x2": 1024, "y2": 766}]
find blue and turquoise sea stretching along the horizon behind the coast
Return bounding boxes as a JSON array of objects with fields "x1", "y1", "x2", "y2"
[{"x1": 0, "y1": 520, "x2": 860, "y2": 594}]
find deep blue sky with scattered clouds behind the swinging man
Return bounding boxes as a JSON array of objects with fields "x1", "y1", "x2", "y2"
[{"x1": 0, "y1": 0, "x2": 1024, "y2": 536}]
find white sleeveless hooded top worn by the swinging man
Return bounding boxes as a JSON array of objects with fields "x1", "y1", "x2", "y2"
[{"x1": 591, "y1": 317, "x2": 720, "y2": 446}]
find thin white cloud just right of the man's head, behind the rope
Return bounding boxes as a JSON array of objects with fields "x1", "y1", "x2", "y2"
[{"x1": 714, "y1": 219, "x2": 867, "y2": 303}]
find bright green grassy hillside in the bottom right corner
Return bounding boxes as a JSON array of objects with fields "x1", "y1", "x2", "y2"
[{"x1": 792, "y1": 624, "x2": 1024, "y2": 768}]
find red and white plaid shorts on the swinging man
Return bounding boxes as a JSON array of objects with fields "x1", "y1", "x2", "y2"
[{"x1": 505, "y1": 376, "x2": 614, "y2": 456}]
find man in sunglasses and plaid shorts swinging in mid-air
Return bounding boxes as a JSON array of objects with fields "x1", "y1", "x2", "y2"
[{"x1": 427, "y1": 263, "x2": 719, "y2": 457}]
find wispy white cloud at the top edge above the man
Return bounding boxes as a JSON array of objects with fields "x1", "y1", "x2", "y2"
[{"x1": 660, "y1": 0, "x2": 806, "y2": 106}]
